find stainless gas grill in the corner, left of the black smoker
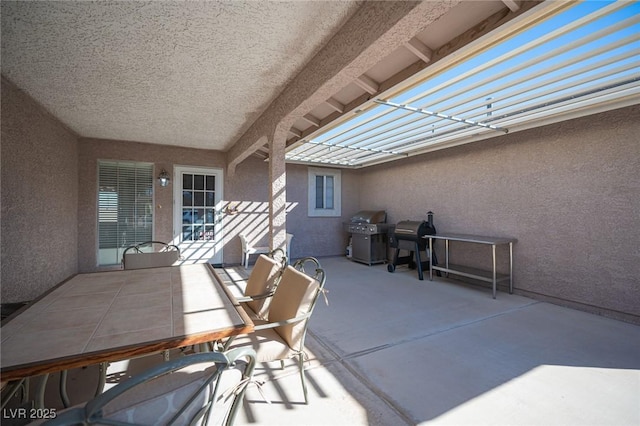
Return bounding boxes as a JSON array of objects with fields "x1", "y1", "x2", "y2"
[{"x1": 344, "y1": 210, "x2": 389, "y2": 265}]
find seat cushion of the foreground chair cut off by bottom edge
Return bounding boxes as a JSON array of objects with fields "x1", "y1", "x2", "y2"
[{"x1": 97, "y1": 364, "x2": 242, "y2": 425}]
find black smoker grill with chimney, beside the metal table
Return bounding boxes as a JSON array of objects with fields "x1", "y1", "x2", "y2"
[{"x1": 387, "y1": 212, "x2": 438, "y2": 280}]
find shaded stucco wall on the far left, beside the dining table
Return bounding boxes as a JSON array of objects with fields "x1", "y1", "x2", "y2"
[{"x1": 0, "y1": 78, "x2": 78, "y2": 303}]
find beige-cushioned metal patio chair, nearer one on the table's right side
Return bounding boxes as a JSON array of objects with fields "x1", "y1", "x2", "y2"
[{"x1": 224, "y1": 257, "x2": 325, "y2": 404}]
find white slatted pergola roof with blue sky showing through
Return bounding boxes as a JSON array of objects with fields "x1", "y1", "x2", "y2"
[{"x1": 286, "y1": 2, "x2": 640, "y2": 167}]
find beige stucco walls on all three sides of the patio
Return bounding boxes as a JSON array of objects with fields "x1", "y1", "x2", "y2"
[{"x1": 0, "y1": 76, "x2": 640, "y2": 322}]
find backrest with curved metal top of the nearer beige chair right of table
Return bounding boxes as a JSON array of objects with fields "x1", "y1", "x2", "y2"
[{"x1": 268, "y1": 258, "x2": 325, "y2": 350}]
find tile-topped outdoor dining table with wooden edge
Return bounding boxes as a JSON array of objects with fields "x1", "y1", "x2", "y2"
[{"x1": 0, "y1": 264, "x2": 254, "y2": 408}]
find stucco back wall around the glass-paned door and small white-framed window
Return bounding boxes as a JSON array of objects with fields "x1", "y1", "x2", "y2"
[{"x1": 78, "y1": 142, "x2": 358, "y2": 272}]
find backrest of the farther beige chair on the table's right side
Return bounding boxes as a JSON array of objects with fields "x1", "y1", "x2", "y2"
[{"x1": 244, "y1": 249, "x2": 287, "y2": 317}]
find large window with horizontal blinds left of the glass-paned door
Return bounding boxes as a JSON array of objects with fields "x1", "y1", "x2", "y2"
[{"x1": 98, "y1": 161, "x2": 153, "y2": 266}]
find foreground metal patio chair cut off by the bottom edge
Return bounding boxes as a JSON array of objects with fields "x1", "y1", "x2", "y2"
[{"x1": 44, "y1": 349, "x2": 255, "y2": 425}]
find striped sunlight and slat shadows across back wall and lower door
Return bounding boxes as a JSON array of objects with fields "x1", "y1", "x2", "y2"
[{"x1": 171, "y1": 201, "x2": 299, "y2": 265}]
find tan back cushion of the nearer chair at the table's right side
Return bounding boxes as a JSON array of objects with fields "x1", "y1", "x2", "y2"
[{"x1": 268, "y1": 266, "x2": 320, "y2": 349}]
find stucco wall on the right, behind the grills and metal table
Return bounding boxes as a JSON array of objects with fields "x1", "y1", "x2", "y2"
[{"x1": 360, "y1": 106, "x2": 640, "y2": 320}]
